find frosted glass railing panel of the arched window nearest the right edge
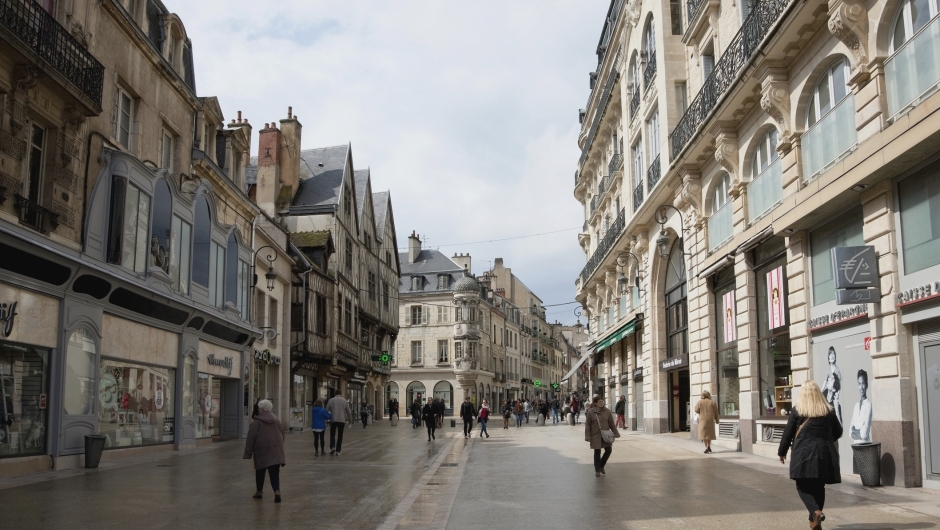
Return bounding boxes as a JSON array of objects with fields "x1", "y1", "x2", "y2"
[{"x1": 885, "y1": 13, "x2": 940, "y2": 116}]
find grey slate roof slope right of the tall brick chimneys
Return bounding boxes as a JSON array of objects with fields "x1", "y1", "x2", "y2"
[{"x1": 292, "y1": 145, "x2": 349, "y2": 208}]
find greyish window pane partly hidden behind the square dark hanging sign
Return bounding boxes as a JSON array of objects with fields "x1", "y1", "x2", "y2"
[{"x1": 809, "y1": 206, "x2": 865, "y2": 305}]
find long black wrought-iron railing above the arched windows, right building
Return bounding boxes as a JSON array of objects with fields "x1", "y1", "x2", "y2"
[{"x1": 669, "y1": 0, "x2": 791, "y2": 160}]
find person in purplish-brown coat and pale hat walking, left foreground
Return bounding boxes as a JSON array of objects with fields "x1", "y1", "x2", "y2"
[{"x1": 242, "y1": 399, "x2": 286, "y2": 502}]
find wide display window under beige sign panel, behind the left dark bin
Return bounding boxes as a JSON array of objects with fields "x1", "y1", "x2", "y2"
[{"x1": 98, "y1": 359, "x2": 176, "y2": 447}]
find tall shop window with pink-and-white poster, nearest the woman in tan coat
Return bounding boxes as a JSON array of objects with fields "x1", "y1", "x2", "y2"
[{"x1": 714, "y1": 267, "x2": 741, "y2": 416}]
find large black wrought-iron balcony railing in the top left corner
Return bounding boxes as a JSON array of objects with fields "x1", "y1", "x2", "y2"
[{"x1": 0, "y1": 0, "x2": 104, "y2": 108}]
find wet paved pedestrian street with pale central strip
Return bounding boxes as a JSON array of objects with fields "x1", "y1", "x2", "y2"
[{"x1": 0, "y1": 420, "x2": 940, "y2": 530}]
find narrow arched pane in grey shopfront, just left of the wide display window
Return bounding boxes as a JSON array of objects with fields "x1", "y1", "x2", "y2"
[{"x1": 63, "y1": 328, "x2": 98, "y2": 416}]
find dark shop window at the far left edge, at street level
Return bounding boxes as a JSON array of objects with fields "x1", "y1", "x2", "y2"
[{"x1": 0, "y1": 341, "x2": 49, "y2": 457}]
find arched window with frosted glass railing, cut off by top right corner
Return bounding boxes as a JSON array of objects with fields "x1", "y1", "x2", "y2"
[{"x1": 885, "y1": 0, "x2": 940, "y2": 116}]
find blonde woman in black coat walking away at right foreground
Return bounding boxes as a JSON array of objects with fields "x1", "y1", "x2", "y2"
[{"x1": 777, "y1": 381, "x2": 842, "y2": 530}]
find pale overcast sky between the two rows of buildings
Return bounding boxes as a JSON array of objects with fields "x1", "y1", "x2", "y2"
[{"x1": 173, "y1": 0, "x2": 610, "y2": 323}]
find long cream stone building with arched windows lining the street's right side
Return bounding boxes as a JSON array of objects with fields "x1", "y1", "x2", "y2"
[{"x1": 575, "y1": 0, "x2": 940, "y2": 486}]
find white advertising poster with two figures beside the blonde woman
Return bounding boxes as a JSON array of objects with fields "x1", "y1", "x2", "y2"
[{"x1": 813, "y1": 325, "x2": 873, "y2": 473}]
